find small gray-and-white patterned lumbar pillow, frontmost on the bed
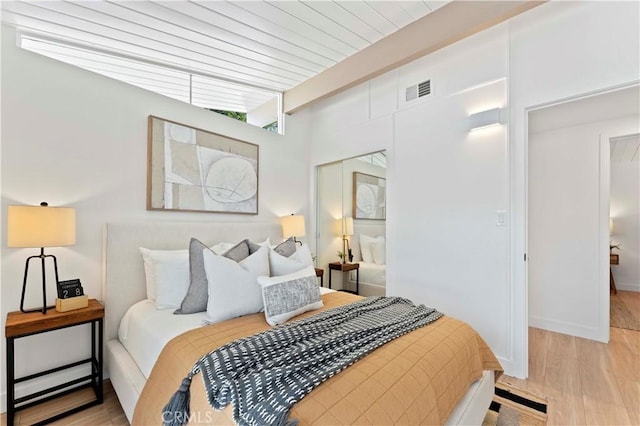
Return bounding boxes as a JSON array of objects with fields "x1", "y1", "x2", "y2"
[{"x1": 258, "y1": 266, "x2": 324, "y2": 325}]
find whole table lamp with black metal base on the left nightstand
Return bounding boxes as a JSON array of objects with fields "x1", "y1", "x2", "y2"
[{"x1": 7, "y1": 202, "x2": 76, "y2": 314}]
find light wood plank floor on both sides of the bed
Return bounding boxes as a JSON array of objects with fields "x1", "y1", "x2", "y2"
[{"x1": 0, "y1": 291, "x2": 640, "y2": 426}]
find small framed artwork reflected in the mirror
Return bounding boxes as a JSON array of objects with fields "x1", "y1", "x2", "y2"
[{"x1": 352, "y1": 172, "x2": 387, "y2": 220}]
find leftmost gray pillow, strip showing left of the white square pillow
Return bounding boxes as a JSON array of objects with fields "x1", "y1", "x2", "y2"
[{"x1": 173, "y1": 238, "x2": 209, "y2": 315}]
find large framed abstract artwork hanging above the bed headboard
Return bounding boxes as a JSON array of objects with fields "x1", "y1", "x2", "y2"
[{"x1": 147, "y1": 116, "x2": 258, "y2": 214}]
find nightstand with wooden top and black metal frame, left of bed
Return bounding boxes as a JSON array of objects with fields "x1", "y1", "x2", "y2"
[{"x1": 5, "y1": 299, "x2": 104, "y2": 426}]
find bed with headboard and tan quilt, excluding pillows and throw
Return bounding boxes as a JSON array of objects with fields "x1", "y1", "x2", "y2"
[{"x1": 103, "y1": 222, "x2": 501, "y2": 424}]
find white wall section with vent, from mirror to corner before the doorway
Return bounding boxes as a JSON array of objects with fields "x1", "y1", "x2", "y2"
[{"x1": 311, "y1": 25, "x2": 510, "y2": 365}]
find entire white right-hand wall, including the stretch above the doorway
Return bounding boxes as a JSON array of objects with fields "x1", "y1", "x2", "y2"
[{"x1": 300, "y1": 2, "x2": 640, "y2": 377}]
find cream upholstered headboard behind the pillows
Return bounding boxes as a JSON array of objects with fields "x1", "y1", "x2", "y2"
[{"x1": 102, "y1": 222, "x2": 282, "y2": 340}]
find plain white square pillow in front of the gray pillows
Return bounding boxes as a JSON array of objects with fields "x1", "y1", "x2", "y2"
[{"x1": 202, "y1": 245, "x2": 269, "y2": 323}]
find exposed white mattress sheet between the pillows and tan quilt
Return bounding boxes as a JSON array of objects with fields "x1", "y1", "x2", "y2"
[{"x1": 118, "y1": 299, "x2": 206, "y2": 378}]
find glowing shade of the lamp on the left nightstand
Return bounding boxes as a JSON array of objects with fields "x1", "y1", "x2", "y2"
[{"x1": 7, "y1": 206, "x2": 76, "y2": 247}]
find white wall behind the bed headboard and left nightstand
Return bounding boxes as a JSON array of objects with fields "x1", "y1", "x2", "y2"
[{"x1": 0, "y1": 26, "x2": 310, "y2": 412}]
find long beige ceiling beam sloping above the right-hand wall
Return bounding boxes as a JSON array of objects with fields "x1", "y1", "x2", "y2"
[{"x1": 284, "y1": 0, "x2": 546, "y2": 114}]
